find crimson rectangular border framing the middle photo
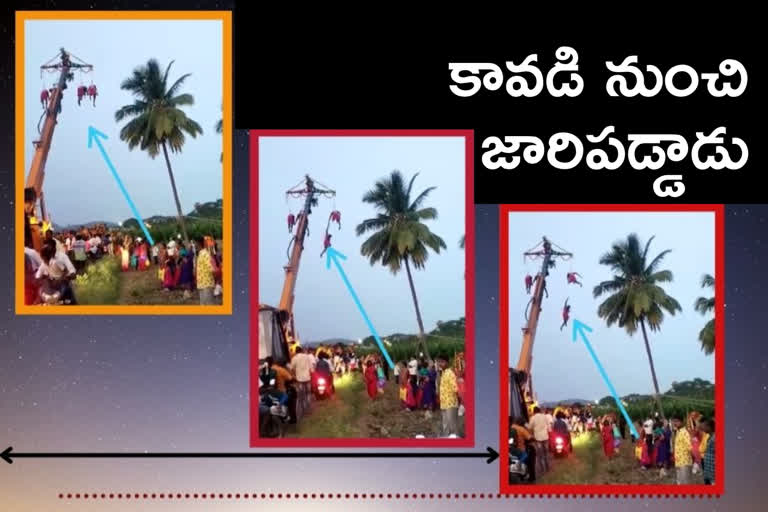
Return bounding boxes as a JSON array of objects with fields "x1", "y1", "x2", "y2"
[{"x1": 249, "y1": 130, "x2": 475, "y2": 448}]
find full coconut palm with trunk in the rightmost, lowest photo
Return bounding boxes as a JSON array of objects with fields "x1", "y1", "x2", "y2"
[{"x1": 592, "y1": 233, "x2": 682, "y2": 418}]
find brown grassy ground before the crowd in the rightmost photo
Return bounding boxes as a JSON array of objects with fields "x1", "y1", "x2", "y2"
[{"x1": 537, "y1": 432, "x2": 704, "y2": 485}]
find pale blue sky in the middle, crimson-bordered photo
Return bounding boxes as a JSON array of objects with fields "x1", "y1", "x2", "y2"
[{"x1": 259, "y1": 137, "x2": 465, "y2": 342}]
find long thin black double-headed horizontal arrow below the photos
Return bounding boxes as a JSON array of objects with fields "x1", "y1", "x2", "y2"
[{"x1": 0, "y1": 446, "x2": 499, "y2": 464}]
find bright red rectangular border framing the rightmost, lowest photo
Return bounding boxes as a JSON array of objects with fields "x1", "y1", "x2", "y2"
[{"x1": 499, "y1": 204, "x2": 725, "y2": 496}]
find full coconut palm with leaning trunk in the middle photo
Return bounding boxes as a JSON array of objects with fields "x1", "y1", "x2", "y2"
[{"x1": 355, "y1": 170, "x2": 446, "y2": 360}]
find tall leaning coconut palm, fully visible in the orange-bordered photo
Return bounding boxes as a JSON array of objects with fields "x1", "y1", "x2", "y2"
[{"x1": 115, "y1": 59, "x2": 203, "y2": 243}]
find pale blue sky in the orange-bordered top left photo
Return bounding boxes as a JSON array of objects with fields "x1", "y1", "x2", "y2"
[{"x1": 24, "y1": 20, "x2": 223, "y2": 225}]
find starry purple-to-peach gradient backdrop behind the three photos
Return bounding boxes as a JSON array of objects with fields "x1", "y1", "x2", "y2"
[{"x1": 0, "y1": 2, "x2": 768, "y2": 512}]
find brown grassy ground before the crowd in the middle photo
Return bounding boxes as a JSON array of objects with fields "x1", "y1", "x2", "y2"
[{"x1": 285, "y1": 373, "x2": 464, "y2": 439}]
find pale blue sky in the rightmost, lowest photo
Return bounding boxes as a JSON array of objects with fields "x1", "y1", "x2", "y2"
[{"x1": 509, "y1": 212, "x2": 715, "y2": 401}]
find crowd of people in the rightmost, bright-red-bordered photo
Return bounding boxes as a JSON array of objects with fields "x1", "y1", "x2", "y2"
[{"x1": 510, "y1": 406, "x2": 715, "y2": 485}]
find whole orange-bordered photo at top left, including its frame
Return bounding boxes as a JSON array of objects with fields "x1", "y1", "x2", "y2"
[{"x1": 14, "y1": 10, "x2": 233, "y2": 315}]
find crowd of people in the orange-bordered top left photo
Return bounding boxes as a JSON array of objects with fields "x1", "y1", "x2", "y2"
[{"x1": 24, "y1": 210, "x2": 222, "y2": 305}]
